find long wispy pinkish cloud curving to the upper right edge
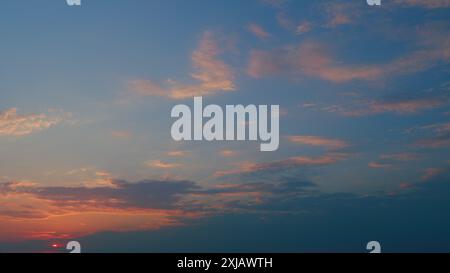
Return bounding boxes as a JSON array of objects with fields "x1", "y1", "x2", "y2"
[{"x1": 247, "y1": 26, "x2": 450, "y2": 83}]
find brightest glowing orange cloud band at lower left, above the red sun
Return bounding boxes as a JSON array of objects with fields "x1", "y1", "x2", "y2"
[{"x1": 0, "y1": 206, "x2": 192, "y2": 241}]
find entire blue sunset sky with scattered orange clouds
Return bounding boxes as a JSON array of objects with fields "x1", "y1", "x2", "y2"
[{"x1": 0, "y1": 0, "x2": 450, "y2": 252}]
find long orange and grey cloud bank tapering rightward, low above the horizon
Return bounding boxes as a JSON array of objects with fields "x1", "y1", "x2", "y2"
[{"x1": 0, "y1": 173, "x2": 320, "y2": 241}]
